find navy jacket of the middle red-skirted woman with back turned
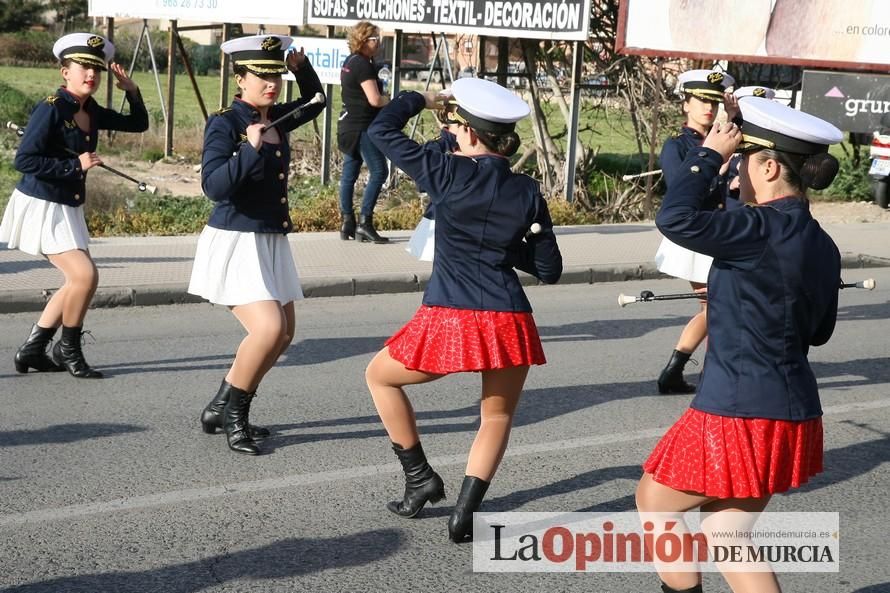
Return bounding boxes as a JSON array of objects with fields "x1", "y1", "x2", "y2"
[{"x1": 368, "y1": 92, "x2": 562, "y2": 311}]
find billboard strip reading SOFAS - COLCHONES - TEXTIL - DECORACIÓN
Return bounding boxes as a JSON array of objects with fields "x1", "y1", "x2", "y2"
[{"x1": 307, "y1": 0, "x2": 590, "y2": 40}]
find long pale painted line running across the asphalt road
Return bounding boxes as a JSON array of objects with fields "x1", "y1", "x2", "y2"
[{"x1": 0, "y1": 399, "x2": 890, "y2": 527}]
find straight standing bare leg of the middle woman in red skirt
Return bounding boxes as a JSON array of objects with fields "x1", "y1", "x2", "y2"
[{"x1": 466, "y1": 366, "x2": 528, "y2": 482}]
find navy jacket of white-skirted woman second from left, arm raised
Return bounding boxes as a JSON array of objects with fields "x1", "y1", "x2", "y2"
[{"x1": 201, "y1": 61, "x2": 324, "y2": 233}]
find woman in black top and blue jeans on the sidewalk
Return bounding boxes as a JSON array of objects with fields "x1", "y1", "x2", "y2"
[{"x1": 337, "y1": 21, "x2": 389, "y2": 243}]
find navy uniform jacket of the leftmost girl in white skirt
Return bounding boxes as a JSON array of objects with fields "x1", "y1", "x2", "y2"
[{"x1": 15, "y1": 88, "x2": 148, "y2": 207}]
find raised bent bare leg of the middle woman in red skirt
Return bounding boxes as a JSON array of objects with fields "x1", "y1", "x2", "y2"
[{"x1": 365, "y1": 347, "x2": 442, "y2": 449}]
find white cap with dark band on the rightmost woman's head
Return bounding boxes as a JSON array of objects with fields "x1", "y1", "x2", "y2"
[{"x1": 739, "y1": 97, "x2": 844, "y2": 154}]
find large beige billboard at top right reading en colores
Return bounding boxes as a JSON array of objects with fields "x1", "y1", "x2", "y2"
[{"x1": 617, "y1": 0, "x2": 890, "y2": 72}]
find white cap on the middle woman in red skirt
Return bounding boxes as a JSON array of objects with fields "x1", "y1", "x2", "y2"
[{"x1": 451, "y1": 78, "x2": 531, "y2": 134}]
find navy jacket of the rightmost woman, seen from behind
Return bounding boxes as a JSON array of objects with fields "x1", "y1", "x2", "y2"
[{"x1": 655, "y1": 148, "x2": 840, "y2": 420}]
